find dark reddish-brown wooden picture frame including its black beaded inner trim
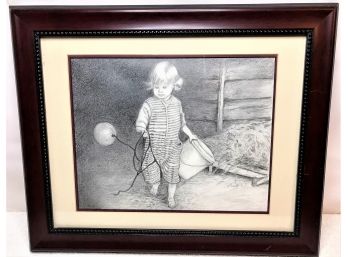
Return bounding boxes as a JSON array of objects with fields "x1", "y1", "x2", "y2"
[{"x1": 10, "y1": 4, "x2": 338, "y2": 256}]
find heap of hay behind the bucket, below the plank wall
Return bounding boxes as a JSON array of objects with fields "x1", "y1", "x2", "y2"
[{"x1": 204, "y1": 121, "x2": 272, "y2": 172}]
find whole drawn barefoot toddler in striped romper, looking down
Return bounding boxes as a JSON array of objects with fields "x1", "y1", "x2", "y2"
[{"x1": 136, "y1": 61, "x2": 197, "y2": 208}]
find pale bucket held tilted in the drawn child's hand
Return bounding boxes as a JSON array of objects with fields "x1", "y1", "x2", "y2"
[{"x1": 179, "y1": 139, "x2": 215, "y2": 179}]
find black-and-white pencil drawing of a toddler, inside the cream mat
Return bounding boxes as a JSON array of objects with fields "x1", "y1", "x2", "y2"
[{"x1": 69, "y1": 56, "x2": 276, "y2": 213}]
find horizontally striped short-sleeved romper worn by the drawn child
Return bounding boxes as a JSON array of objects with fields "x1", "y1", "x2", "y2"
[{"x1": 136, "y1": 96, "x2": 185, "y2": 184}]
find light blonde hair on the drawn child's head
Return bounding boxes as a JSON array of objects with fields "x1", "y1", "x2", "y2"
[{"x1": 146, "y1": 61, "x2": 184, "y2": 91}]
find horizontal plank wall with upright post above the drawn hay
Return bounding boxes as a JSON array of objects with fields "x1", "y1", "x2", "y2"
[{"x1": 186, "y1": 58, "x2": 274, "y2": 132}]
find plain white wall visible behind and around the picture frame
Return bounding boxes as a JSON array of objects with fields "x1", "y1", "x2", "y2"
[{"x1": 2, "y1": 0, "x2": 347, "y2": 213}]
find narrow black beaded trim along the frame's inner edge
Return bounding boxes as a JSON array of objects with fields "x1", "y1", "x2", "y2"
[{"x1": 34, "y1": 29, "x2": 313, "y2": 237}]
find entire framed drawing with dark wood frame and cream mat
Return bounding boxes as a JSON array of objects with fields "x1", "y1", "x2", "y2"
[{"x1": 11, "y1": 4, "x2": 338, "y2": 256}]
